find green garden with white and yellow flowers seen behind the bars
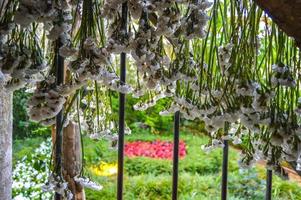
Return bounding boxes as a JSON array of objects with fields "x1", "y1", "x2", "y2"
[{"x1": 13, "y1": 90, "x2": 301, "y2": 200}]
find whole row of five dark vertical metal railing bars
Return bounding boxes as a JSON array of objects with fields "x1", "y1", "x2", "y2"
[{"x1": 51, "y1": 2, "x2": 272, "y2": 200}]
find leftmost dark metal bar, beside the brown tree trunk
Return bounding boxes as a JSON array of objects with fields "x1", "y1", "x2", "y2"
[{"x1": 55, "y1": 38, "x2": 65, "y2": 200}]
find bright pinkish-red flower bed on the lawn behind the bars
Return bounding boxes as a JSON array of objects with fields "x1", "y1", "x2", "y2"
[{"x1": 125, "y1": 140, "x2": 187, "y2": 160}]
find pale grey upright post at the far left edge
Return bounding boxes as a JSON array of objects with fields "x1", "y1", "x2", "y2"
[{"x1": 0, "y1": 85, "x2": 13, "y2": 200}]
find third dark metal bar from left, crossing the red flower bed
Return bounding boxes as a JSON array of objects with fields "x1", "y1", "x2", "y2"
[{"x1": 172, "y1": 111, "x2": 180, "y2": 200}]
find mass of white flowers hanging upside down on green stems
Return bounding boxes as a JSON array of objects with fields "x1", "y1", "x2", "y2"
[{"x1": 0, "y1": 0, "x2": 301, "y2": 199}]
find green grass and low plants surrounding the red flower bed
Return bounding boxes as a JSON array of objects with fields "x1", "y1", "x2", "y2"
[{"x1": 14, "y1": 130, "x2": 301, "y2": 200}]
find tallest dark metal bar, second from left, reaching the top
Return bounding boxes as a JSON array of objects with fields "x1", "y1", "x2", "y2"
[{"x1": 117, "y1": 2, "x2": 128, "y2": 200}]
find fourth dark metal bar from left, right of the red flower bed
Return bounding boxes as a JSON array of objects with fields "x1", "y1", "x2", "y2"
[{"x1": 221, "y1": 140, "x2": 229, "y2": 200}]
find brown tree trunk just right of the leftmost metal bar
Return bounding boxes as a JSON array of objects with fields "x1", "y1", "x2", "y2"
[{"x1": 62, "y1": 122, "x2": 85, "y2": 200}]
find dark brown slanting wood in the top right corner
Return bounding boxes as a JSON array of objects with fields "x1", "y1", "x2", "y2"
[{"x1": 255, "y1": 0, "x2": 301, "y2": 48}]
